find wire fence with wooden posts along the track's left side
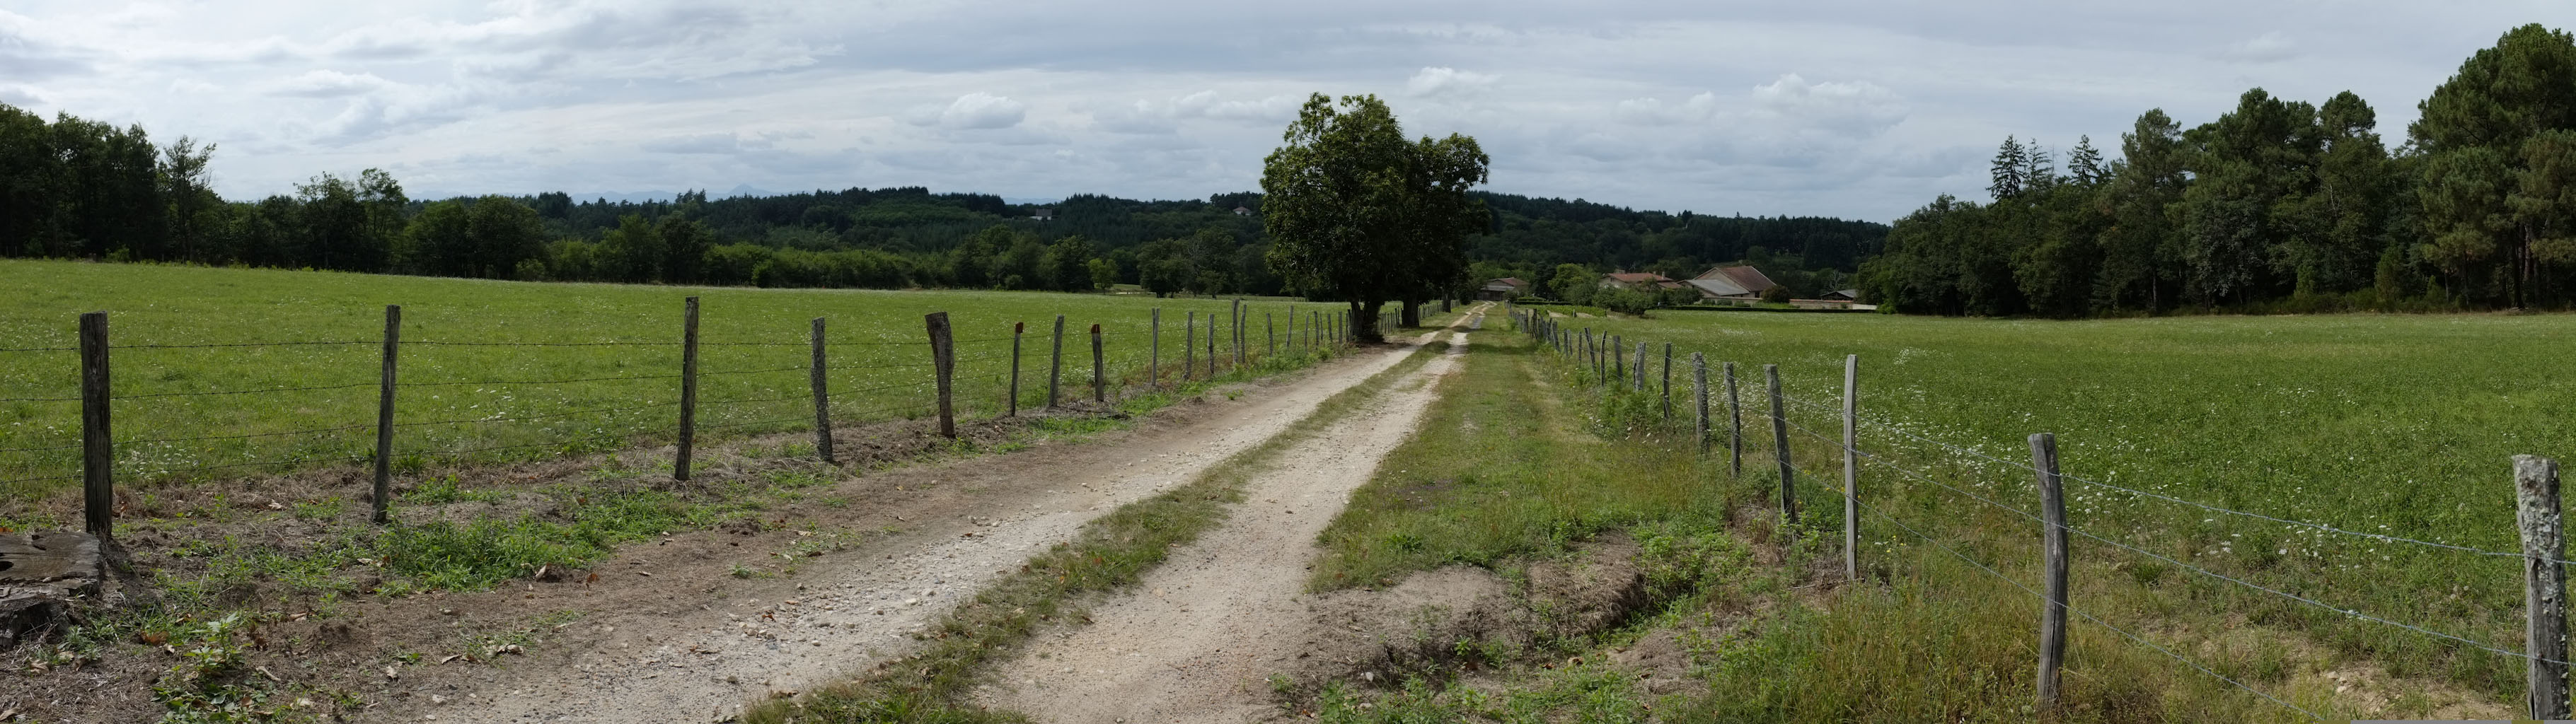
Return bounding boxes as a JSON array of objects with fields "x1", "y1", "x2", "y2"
[{"x1": 0, "y1": 296, "x2": 1401, "y2": 531}]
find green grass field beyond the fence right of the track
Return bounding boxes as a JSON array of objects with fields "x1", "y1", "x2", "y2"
[{"x1": 1504, "y1": 306, "x2": 2576, "y2": 703}]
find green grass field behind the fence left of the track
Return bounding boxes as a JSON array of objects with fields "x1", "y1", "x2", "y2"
[{"x1": 0, "y1": 260, "x2": 1339, "y2": 495}]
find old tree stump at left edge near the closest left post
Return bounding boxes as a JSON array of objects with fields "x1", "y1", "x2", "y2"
[{"x1": 0, "y1": 531, "x2": 105, "y2": 641}]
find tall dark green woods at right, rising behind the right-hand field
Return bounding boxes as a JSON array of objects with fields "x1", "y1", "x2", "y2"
[{"x1": 1862, "y1": 25, "x2": 2576, "y2": 317}]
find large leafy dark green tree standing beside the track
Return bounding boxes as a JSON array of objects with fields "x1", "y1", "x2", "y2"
[{"x1": 1262, "y1": 93, "x2": 1491, "y2": 340}]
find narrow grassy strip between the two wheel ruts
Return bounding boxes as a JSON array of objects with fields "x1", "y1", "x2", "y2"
[{"x1": 742, "y1": 332, "x2": 1445, "y2": 724}]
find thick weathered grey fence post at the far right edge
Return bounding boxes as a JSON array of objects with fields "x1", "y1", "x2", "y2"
[{"x1": 2514, "y1": 456, "x2": 2568, "y2": 719}]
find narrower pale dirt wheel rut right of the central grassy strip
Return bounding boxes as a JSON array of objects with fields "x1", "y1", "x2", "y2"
[{"x1": 984, "y1": 315, "x2": 1476, "y2": 724}]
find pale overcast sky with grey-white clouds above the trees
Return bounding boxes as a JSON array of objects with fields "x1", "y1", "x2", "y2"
[{"x1": 0, "y1": 0, "x2": 2568, "y2": 221}]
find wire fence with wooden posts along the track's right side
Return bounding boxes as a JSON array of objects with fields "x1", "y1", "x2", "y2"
[{"x1": 1512, "y1": 312, "x2": 2576, "y2": 721}]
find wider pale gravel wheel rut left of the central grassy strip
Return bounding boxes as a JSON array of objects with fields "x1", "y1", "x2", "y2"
[{"x1": 388, "y1": 317, "x2": 1463, "y2": 724}]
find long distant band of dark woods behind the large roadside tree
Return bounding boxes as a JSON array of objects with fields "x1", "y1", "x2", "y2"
[{"x1": 0, "y1": 98, "x2": 1885, "y2": 299}]
